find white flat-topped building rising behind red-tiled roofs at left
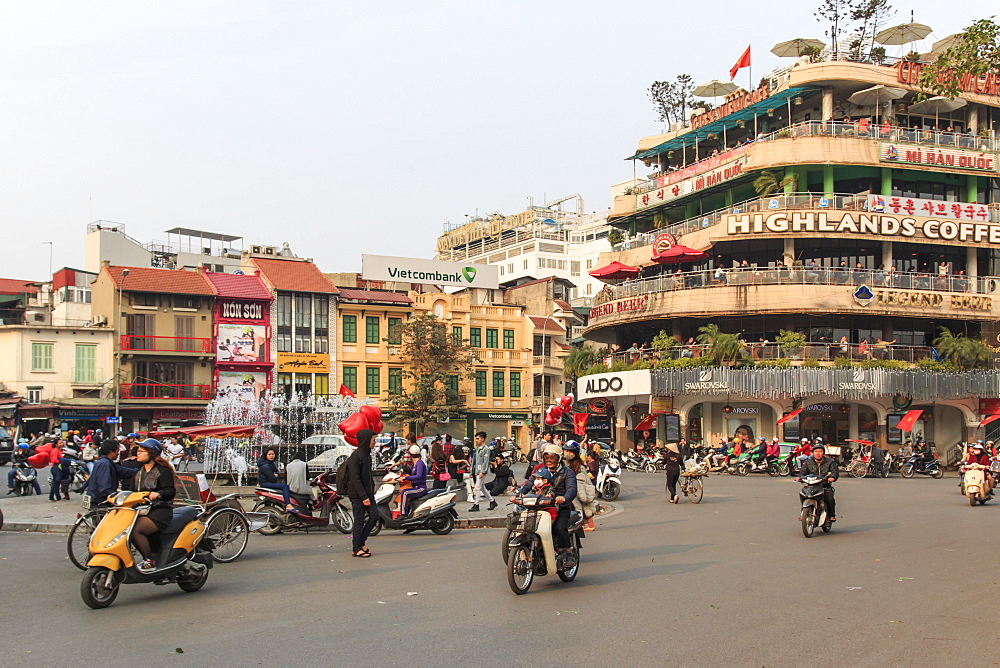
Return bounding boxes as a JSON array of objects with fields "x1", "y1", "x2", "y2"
[{"x1": 84, "y1": 220, "x2": 244, "y2": 274}]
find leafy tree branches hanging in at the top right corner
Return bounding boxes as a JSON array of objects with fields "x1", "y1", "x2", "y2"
[{"x1": 920, "y1": 16, "x2": 1000, "y2": 99}]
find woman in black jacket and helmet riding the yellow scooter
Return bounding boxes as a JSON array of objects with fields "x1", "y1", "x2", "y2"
[{"x1": 132, "y1": 438, "x2": 177, "y2": 571}]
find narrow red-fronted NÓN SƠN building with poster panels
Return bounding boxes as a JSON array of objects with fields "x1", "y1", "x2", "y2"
[{"x1": 205, "y1": 272, "x2": 274, "y2": 402}]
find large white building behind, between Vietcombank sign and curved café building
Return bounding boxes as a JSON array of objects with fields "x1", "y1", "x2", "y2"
[{"x1": 436, "y1": 193, "x2": 625, "y2": 305}]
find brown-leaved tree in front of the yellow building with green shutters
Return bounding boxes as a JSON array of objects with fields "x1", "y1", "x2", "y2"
[{"x1": 387, "y1": 315, "x2": 476, "y2": 434}]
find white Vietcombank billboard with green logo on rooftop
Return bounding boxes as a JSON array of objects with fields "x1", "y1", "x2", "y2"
[{"x1": 361, "y1": 255, "x2": 500, "y2": 289}]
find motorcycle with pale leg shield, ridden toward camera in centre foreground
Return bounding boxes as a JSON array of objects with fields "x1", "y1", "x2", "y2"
[{"x1": 507, "y1": 494, "x2": 583, "y2": 595}]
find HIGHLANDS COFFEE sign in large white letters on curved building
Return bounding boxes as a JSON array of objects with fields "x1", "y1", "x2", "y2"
[{"x1": 723, "y1": 211, "x2": 1000, "y2": 245}]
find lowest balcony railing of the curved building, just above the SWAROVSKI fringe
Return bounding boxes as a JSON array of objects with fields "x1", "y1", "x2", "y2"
[{"x1": 601, "y1": 341, "x2": 941, "y2": 366}]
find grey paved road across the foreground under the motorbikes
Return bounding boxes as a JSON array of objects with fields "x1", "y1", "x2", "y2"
[{"x1": 0, "y1": 473, "x2": 984, "y2": 666}]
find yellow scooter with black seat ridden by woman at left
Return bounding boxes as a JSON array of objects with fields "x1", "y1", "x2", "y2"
[{"x1": 80, "y1": 492, "x2": 212, "y2": 609}]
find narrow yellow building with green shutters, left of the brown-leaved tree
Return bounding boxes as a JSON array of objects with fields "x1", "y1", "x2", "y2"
[{"x1": 334, "y1": 281, "x2": 413, "y2": 406}]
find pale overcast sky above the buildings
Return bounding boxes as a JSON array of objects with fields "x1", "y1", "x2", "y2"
[{"x1": 0, "y1": 0, "x2": 997, "y2": 280}]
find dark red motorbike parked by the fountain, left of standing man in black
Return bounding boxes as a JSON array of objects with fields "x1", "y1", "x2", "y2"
[{"x1": 253, "y1": 471, "x2": 354, "y2": 536}]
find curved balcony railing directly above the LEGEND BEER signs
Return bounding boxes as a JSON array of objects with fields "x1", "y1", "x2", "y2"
[{"x1": 597, "y1": 264, "x2": 1000, "y2": 304}]
